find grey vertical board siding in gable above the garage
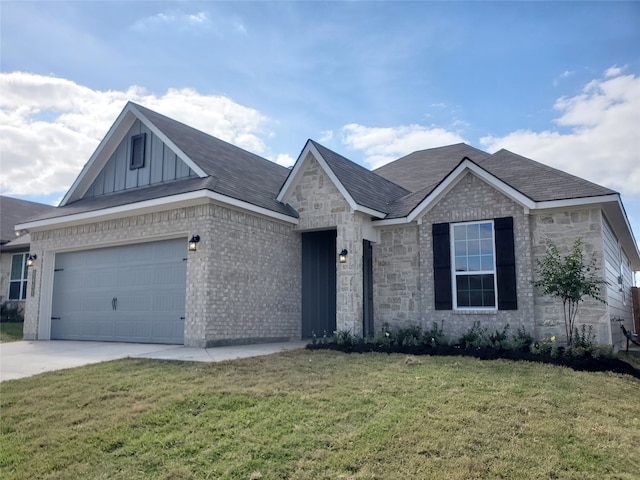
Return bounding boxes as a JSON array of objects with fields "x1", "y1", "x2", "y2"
[{"x1": 84, "y1": 120, "x2": 197, "y2": 198}]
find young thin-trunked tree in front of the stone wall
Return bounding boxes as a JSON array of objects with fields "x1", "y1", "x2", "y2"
[{"x1": 534, "y1": 238, "x2": 607, "y2": 345}]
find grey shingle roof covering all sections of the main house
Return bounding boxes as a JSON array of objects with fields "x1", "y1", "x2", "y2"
[{"x1": 22, "y1": 104, "x2": 616, "y2": 227}]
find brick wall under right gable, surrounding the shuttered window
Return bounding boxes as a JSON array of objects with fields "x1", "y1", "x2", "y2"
[{"x1": 418, "y1": 173, "x2": 536, "y2": 340}]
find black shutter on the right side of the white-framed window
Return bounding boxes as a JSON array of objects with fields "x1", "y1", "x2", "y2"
[{"x1": 493, "y1": 217, "x2": 518, "y2": 310}]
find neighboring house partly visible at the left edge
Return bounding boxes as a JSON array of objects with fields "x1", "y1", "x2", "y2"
[{"x1": 0, "y1": 196, "x2": 55, "y2": 310}]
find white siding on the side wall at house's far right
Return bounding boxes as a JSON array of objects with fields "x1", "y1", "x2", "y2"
[{"x1": 602, "y1": 217, "x2": 633, "y2": 346}]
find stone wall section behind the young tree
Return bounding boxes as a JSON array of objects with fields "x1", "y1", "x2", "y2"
[{"x1": 531, "y1": 208, "x2": 611, "y2": 344}]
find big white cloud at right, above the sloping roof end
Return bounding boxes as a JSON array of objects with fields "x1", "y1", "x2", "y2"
[{"x1": 480, "y1": 67, "x2": 640, "y2": 195}]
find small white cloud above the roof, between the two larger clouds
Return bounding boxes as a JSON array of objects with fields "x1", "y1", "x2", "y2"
[{"x1": 342, "y1": 123, "x2": 465, "y2": 168}]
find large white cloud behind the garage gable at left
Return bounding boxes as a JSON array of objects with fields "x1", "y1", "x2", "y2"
[{"x1": 0, "y1": 72, "x2": 272, "y2": 195}]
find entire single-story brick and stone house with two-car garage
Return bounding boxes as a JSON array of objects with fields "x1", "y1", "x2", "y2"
[{"x1": 18, "y1": 103, "x2": 640, "y2": 347}]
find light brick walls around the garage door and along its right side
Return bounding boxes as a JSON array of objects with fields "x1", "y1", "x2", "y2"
[{"x1": 24, "y1": 203, "x2": 301, "y2": 347}]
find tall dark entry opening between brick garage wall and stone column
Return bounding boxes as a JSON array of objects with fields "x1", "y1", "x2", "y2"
[{"x1": 302, "y1": 230, "x2": 336, "y2": 338}]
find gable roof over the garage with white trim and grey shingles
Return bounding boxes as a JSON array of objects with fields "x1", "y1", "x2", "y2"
[{"x1": 37, "y1": 102, "x2": 297, "y2": 225}]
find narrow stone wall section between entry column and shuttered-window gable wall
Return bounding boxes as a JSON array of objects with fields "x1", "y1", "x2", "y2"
[{"x1": 373, "y1": 224, "x2": 422, "y2": 332}]
